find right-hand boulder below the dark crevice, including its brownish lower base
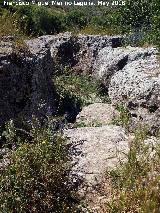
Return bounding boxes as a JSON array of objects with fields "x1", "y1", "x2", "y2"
[{"x1": 108, "y1": 48, "x2": 160, "y2": 130}]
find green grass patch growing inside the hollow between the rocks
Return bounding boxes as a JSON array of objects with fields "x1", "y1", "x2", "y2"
[{"x1": 53, "y1": 68, "x2": 109, "y2": 111}]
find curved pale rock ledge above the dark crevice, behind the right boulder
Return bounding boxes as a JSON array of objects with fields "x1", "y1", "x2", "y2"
[{"x1": 94, "y1": 46, "x2": 156, "y2": 87}]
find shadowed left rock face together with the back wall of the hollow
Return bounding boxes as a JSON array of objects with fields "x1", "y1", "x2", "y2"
[{"x1": 0, "y1": 33, "x2": 121, "y2": 125}]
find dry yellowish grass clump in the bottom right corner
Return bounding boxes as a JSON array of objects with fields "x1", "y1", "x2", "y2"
[{"x1": 106, "y1": 129, "x2": 160, "y2": 213}]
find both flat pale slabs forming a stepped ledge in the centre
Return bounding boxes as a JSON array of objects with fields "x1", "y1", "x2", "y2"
[{"x1": 64, "y1": 103, "x2": 129, "y2": 188}]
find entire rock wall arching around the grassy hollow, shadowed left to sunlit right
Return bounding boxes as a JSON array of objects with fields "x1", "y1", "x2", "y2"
[{"x1": 0, "y1": 33, "x2": 160, "y2": 129}]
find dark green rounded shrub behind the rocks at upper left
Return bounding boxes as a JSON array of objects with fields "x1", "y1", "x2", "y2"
[{"x1": 16, "y1": 6, "x2": 64, "y2": 36}]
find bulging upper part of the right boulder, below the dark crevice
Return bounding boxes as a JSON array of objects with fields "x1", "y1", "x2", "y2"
[{"x1": 109, "y1": 48, "x2": 160, "y2": 104}]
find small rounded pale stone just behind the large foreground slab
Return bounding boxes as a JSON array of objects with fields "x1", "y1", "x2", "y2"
[{"x1": 76, "y1": 103, "x2": 118, "y2": 126}]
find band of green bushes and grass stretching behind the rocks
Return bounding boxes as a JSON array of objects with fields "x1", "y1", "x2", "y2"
[{"x1": 0, "y1": 0, "x2": 160, "y2": 47}]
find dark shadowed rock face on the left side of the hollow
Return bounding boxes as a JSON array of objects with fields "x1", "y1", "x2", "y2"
[{"x1": 0, "y1": 37, "x2": 55, "y2": 125}]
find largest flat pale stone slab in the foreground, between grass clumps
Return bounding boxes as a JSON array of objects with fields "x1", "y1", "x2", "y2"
[{"x1": 64, "y1": 125, "x2": 129, "y2": 186}]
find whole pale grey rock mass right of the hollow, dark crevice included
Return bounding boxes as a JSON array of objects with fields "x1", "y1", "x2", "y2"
[{"x1": 94, "y1": 47, "x2": 160, "y2": 131}]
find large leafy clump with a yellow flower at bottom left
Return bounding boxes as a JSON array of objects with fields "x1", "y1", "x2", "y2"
[{"x1": 0, "y1": 120, "x2": 77, "y2": 212}]
